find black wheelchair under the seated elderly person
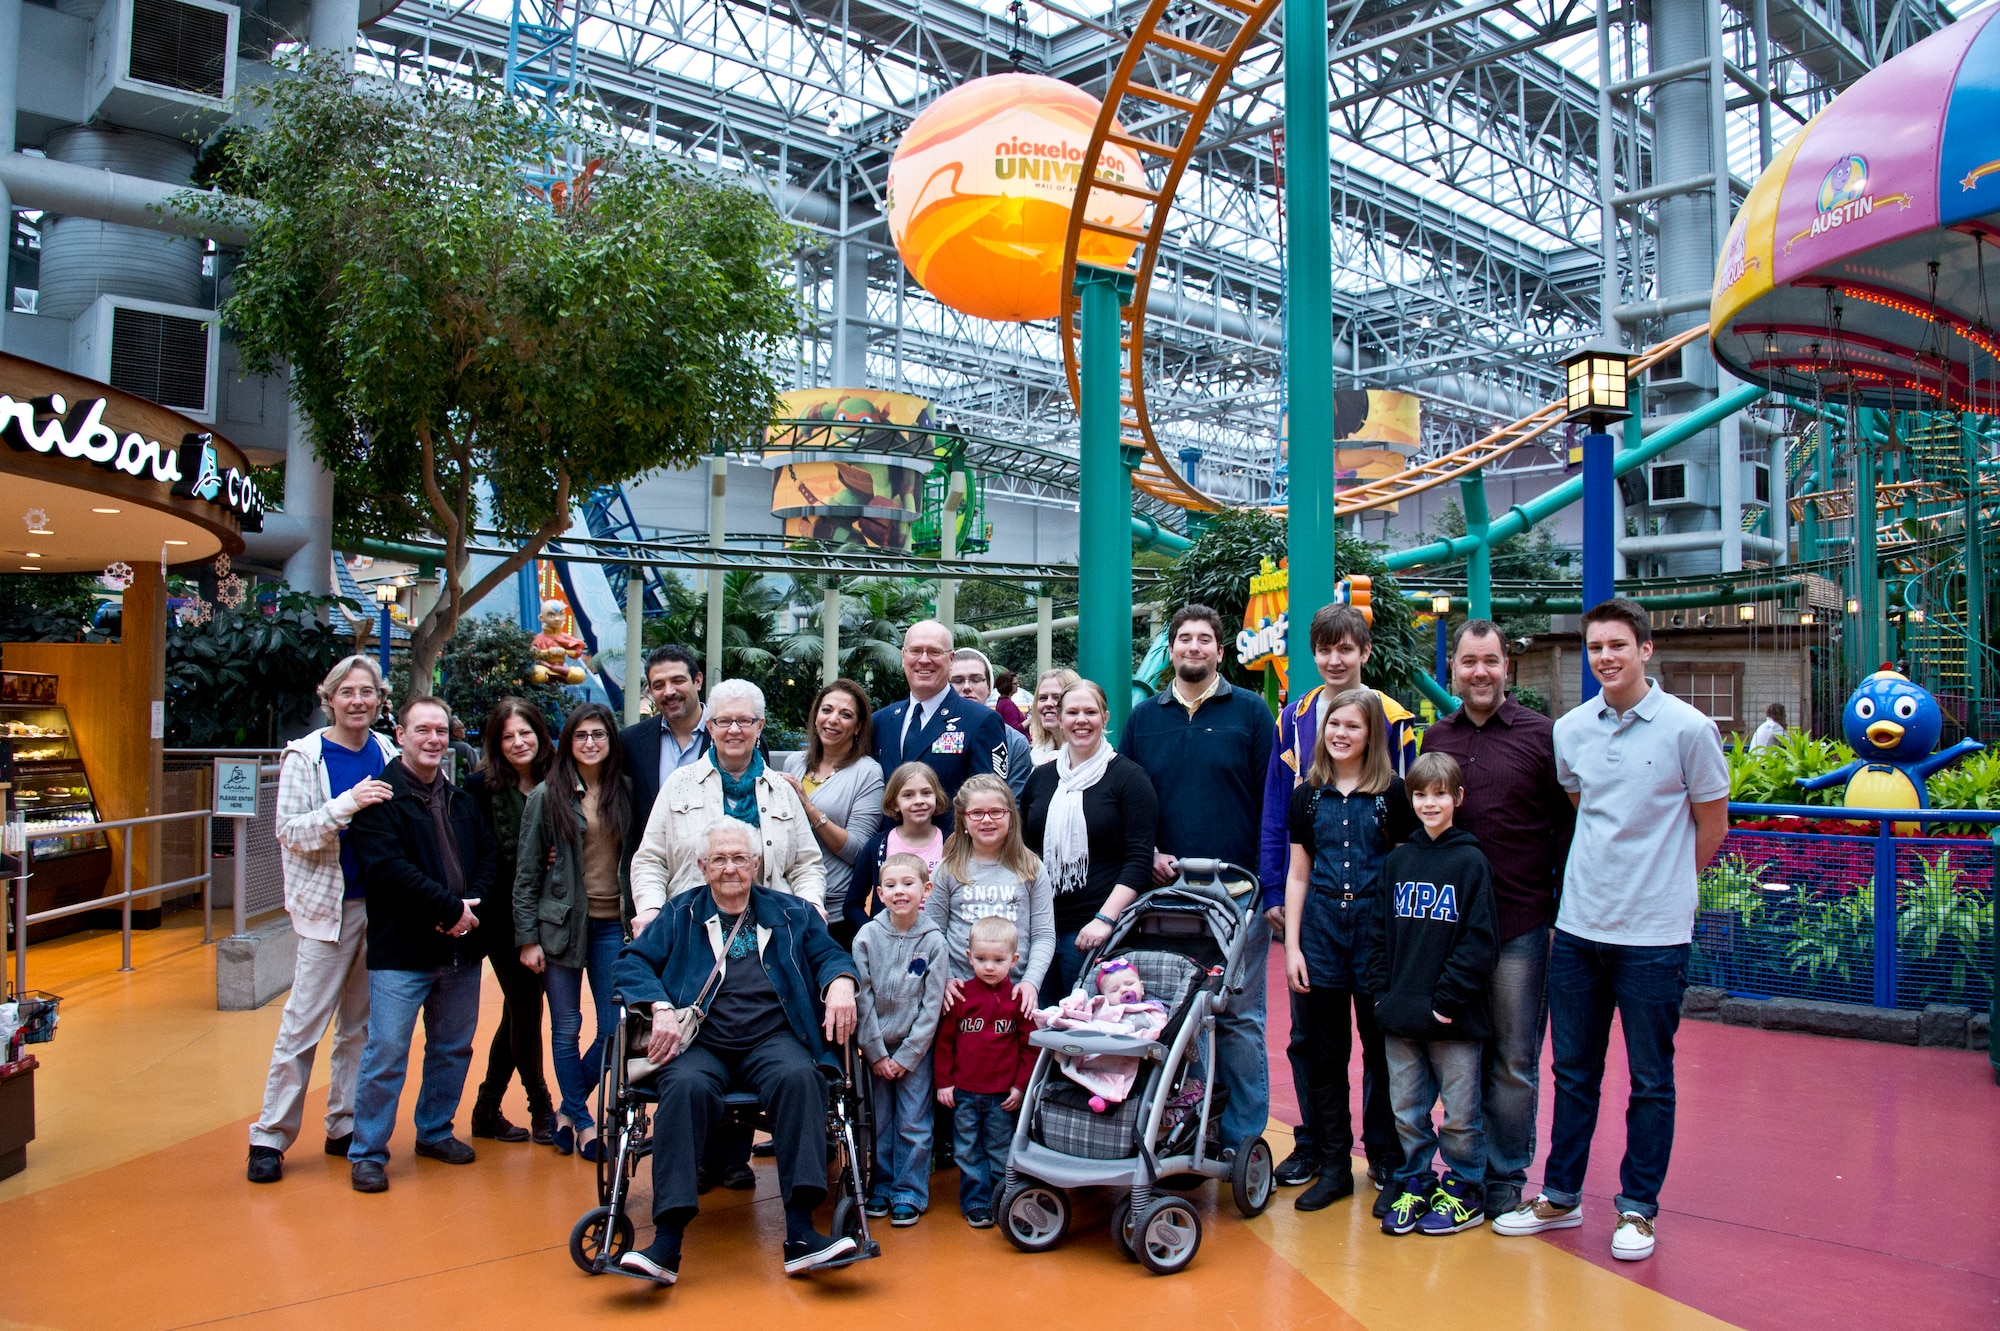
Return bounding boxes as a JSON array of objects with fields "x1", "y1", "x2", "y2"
[{"x1": 570, "y1": 1003, "x2": 882, "y2": 1275}]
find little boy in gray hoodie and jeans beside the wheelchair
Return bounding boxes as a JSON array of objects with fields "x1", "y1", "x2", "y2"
[{"x1": 854, "y1": 855, "x2": 950, "y2": 1227}]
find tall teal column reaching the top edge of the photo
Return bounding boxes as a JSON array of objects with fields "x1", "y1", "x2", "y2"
[{"x1": 1284, "y1": 0, "x2": 1336, "y2": 679}]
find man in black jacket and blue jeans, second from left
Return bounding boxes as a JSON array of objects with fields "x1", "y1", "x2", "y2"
[{"x1": 348, "y1": 697, "x2": 500, "y2": 1193}]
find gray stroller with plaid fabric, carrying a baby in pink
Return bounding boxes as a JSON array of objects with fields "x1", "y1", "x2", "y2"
[{"x1": 998, "y1": 859, "x2": 1272, "y2": 1275}]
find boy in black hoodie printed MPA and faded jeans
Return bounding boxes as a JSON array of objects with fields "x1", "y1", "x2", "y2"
[{"x1": 1364, "y1": 753, "x2": 1500, "y2": 1235}]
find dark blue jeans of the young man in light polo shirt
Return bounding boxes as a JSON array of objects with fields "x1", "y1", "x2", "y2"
[{"x1": 1542, "y1": 929, "x2": 1688, "y2": 1219}]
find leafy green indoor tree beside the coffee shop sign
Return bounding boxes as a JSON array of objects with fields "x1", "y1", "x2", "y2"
[{"x1": 182, "y1": 56, "x2": 798, "y2": 679}]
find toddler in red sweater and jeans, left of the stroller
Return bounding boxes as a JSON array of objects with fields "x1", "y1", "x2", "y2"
[{"x1": 932, "y1": 915, "x2": 1034, "y2": 1229}]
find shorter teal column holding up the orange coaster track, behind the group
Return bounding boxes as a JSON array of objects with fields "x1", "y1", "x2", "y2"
[{"x1": 1076, "y1": 259, "x2": 1144, "y2": 739}]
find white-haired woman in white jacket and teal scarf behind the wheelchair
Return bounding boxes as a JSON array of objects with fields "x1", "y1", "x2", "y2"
[{"x1": 632, "y1": 679, "x2": 826, "y2": 931}]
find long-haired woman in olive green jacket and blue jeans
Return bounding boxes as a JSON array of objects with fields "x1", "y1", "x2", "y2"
[{"x1": 514, "y1": 703, "x2": 636, "y2": 1159}]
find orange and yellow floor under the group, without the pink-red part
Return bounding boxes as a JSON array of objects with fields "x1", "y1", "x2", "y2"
[{"x1": 0, "y1": 921, "x2": 1968, "y2": 1331}]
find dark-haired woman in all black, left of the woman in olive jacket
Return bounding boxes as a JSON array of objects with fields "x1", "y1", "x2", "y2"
[{"x1": 466, "y1": 697, "x2": 556, "y2": 1145}]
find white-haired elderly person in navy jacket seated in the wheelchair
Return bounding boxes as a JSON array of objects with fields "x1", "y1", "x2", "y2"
[{"x1": 612, "y1": 819, "x2": 864, "y2": 1285}]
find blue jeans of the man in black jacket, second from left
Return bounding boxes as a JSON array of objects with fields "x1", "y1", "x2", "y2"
[{"x1": 348, "y1": 959, "x2": 486, "y2": 1165}]
